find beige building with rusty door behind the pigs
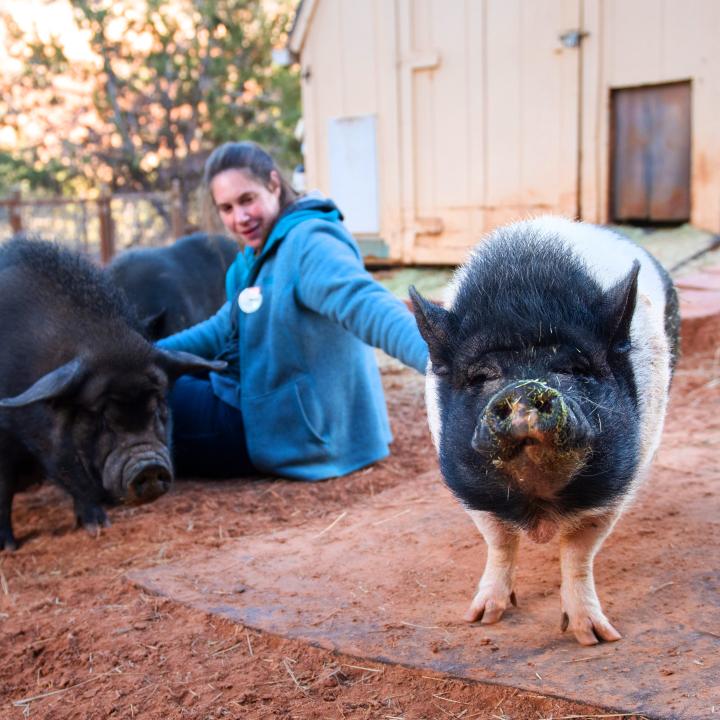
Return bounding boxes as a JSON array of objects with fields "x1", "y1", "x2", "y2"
[{"x1": 290, "y1": 0, "x2": 720, "y2": 264}]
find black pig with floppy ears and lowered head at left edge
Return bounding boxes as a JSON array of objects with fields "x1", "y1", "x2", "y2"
[{"x1": 0, "y1": 238, "x2": 225, "y2": 549}]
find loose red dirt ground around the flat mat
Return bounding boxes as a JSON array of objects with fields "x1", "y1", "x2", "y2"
[{"x1": 0, "y1": 337, "x2": 720, "y2": 720}]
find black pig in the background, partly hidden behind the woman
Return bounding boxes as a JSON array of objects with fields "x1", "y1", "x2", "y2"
[{"x1": 107, "y1": 233, "x2": 238, "y2": 340}]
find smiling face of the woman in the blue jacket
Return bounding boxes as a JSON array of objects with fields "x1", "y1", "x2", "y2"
[{"x1": 210, "y1": 168, "x2": 280, "y2": 253}]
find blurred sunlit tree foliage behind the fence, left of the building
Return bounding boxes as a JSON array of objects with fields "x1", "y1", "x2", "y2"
[{"x1": 0, "y1": 0, "x2": 300, "y2": 197}]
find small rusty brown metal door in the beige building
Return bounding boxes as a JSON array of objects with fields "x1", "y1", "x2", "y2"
[{"x1": 610, "y1": 82, "x2": 691, "y2": 223}]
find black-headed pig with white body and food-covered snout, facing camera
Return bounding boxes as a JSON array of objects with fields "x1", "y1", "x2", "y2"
[{"x1": 411, "y1": 216, "x2": 679, "y2": 645}]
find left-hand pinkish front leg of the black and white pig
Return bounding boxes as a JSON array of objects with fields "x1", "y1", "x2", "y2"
[{"x1": 464, "y1": 510, "x2": 520, "y2": 625}]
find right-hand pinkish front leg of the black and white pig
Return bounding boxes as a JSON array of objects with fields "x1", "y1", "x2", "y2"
[{"x1": 560, "y1": 510, "x2": 622, "y2": 645}]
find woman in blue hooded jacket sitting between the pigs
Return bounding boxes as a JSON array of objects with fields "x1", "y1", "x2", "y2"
[{"x1": 158, "y1": 142, "x2": 428, "y2": 480}]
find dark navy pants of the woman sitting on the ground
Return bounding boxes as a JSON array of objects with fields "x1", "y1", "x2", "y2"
[{"x1": 169, "y1": 375, "x2": 256, "y2": 478}]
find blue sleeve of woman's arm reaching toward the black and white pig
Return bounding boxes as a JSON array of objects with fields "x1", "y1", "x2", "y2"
[{"x1": 297, "y1": 230, "x2": 428, "y2": 373}]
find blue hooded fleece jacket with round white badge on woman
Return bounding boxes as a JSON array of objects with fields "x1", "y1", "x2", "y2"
[{"x1": 158, "y1": 196, "x2": 428, "y2": 480}]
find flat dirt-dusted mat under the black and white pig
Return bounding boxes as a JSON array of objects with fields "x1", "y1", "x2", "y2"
[{"x1": 131, "y1": 442, "x2": 720, "y2": 720}]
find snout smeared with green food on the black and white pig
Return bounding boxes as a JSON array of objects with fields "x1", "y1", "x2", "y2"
[{"x1": 476, "y1": 380, "x2": 568, "y2": 449}]
